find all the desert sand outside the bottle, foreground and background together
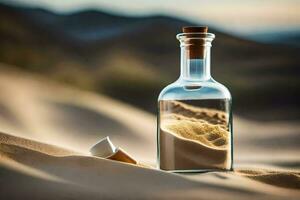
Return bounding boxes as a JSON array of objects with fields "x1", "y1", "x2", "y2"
[{"x1": 0, "y1": 65, "x2": 300, "y2": 200}]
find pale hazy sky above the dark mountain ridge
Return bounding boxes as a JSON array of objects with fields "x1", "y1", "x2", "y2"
[{"x1": 4, "y1": 0, "x2": 300, "y2": 34}]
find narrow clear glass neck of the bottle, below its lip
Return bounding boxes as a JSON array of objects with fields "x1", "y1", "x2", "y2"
[{"x1": 180, "y1": 43, "x2": 211, "y2": 81}]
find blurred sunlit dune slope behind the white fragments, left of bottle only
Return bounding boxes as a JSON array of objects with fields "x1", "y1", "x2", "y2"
[{"x1": 0, "y1": 65, "x2": 156, "y2": 162}]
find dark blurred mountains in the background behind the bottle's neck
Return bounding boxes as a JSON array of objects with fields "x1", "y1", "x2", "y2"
[{"x1": 0, "y1": 4, "x2": 300, "y2": 120}]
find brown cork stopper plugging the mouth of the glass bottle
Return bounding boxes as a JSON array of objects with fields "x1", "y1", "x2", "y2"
[{"x1": 182, "y1": 26, "x2": 208, "y2": 59}]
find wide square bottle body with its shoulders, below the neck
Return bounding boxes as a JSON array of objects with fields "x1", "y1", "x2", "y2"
[{"x1": 157, "y1": 80, "x2": 233, "y2": 172}]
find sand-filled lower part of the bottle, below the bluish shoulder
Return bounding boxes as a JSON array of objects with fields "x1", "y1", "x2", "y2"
[{"x1": 159, "y1": 100, "x2": 231, "y2": 171}]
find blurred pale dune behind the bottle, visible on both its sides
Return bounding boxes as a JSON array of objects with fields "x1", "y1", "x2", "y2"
[{"x1": 0, "y1": 64, "x2": 300, "y2": 168}]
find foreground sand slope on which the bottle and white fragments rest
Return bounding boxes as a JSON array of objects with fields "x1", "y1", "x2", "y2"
[{"x1": 0, "y1": 133, "x2": 300, "y2": 199}]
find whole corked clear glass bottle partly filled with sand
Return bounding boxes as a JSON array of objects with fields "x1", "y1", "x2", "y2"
[{"x1": 157, "y1": 27, "x2": 233, "y2": 172}]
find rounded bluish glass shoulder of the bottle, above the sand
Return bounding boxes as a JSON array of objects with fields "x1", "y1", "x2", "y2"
[{"x1": 158, "y1": 79, "x2": 231, "y2": 100}]
